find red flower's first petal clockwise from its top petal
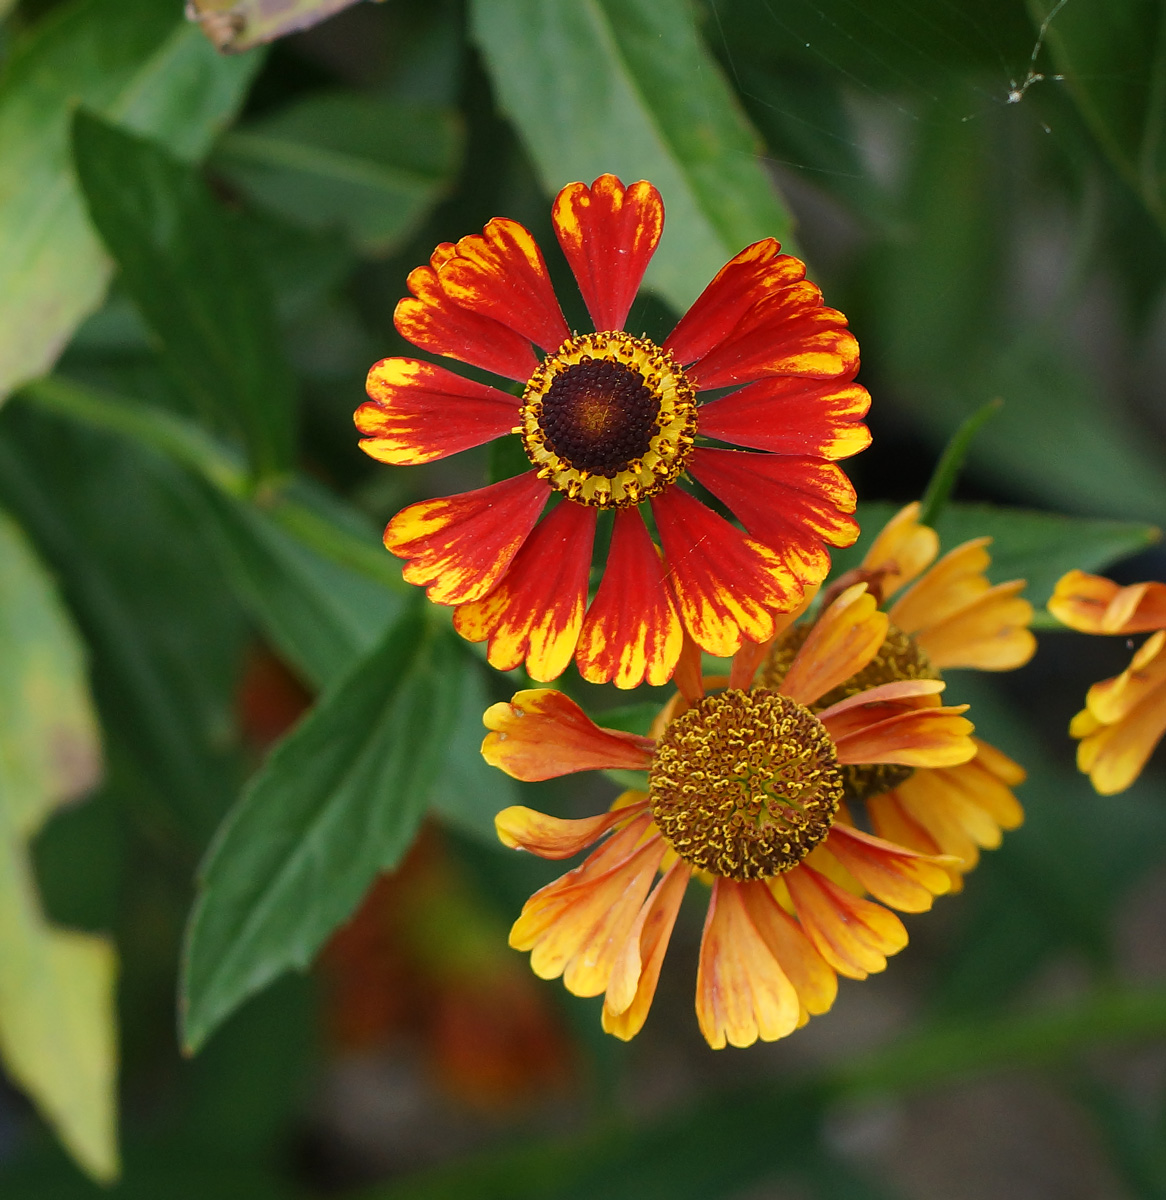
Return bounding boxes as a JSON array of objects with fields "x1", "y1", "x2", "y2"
[{"x1": 663, "y1": 238, "x2": 806, "y2": 362}]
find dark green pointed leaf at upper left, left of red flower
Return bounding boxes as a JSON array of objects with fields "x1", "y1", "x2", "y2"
[{"x1": 73, "y1": 110, "x2": 295, "y2": 478}]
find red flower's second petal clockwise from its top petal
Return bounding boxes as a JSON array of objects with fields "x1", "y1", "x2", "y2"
[{"x1": 687, "y1": 280, "x2": 859, "y2": 391}]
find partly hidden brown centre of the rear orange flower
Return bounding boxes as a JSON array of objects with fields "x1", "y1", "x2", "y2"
[{"x1": 757, "y1": 625, "x2": 940, "y2": 800}]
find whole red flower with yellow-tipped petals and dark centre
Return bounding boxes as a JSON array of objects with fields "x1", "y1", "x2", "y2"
[{"x1": 356, "y1": 175, "x2": 870, "y2": 688}]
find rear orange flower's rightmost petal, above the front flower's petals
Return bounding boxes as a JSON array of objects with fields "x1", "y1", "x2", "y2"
[{"x1": 911, "y1": 580, "x2": 1036, "y2": 671}]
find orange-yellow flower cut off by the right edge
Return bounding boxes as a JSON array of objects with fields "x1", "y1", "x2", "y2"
[{"x1": 1048, "y1": 571, "x2": 1166, "y2": 796}]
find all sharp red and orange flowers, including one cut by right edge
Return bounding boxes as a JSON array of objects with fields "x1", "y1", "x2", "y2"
[{"x1": 356, "y1": 175, "x2": 1166, "y2": 1046}]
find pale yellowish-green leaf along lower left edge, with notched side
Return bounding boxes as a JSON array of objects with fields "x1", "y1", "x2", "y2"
[{"x1": 0, "y1": 515, "x2": 118, "y2": 1181}]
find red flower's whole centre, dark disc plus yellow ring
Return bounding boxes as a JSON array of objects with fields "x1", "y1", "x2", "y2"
[{"x1": 519, "y1": 332, "x2": 696, "y2": 509}]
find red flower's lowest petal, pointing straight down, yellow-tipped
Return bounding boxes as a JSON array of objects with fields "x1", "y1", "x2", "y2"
[{"x1": 576, "y1": 509, "x2": 684, "y2": 688}]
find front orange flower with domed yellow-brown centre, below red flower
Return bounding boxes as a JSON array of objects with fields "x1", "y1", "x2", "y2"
[{"x1": 482, "y1": 583, "x2": 976, "y2": 1048}]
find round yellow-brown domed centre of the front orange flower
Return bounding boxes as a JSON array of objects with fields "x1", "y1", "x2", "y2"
[{"x1": 648, "y1": 689, "x2": 842, "y2": 881}]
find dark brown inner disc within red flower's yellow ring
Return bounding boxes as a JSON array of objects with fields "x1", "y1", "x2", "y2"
[{"x1": 539, "y1": 358, "x2": 660, "y2": 479}]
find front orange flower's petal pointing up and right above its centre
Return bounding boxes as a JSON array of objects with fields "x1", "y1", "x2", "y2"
[{"x1": 779, "y1": 583, "x2": 888, "y2": 704}]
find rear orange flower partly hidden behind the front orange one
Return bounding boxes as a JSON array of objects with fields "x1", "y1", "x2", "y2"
[{"x1": 758, "y1": 504, "x2": 1036, "y2": 890}]
